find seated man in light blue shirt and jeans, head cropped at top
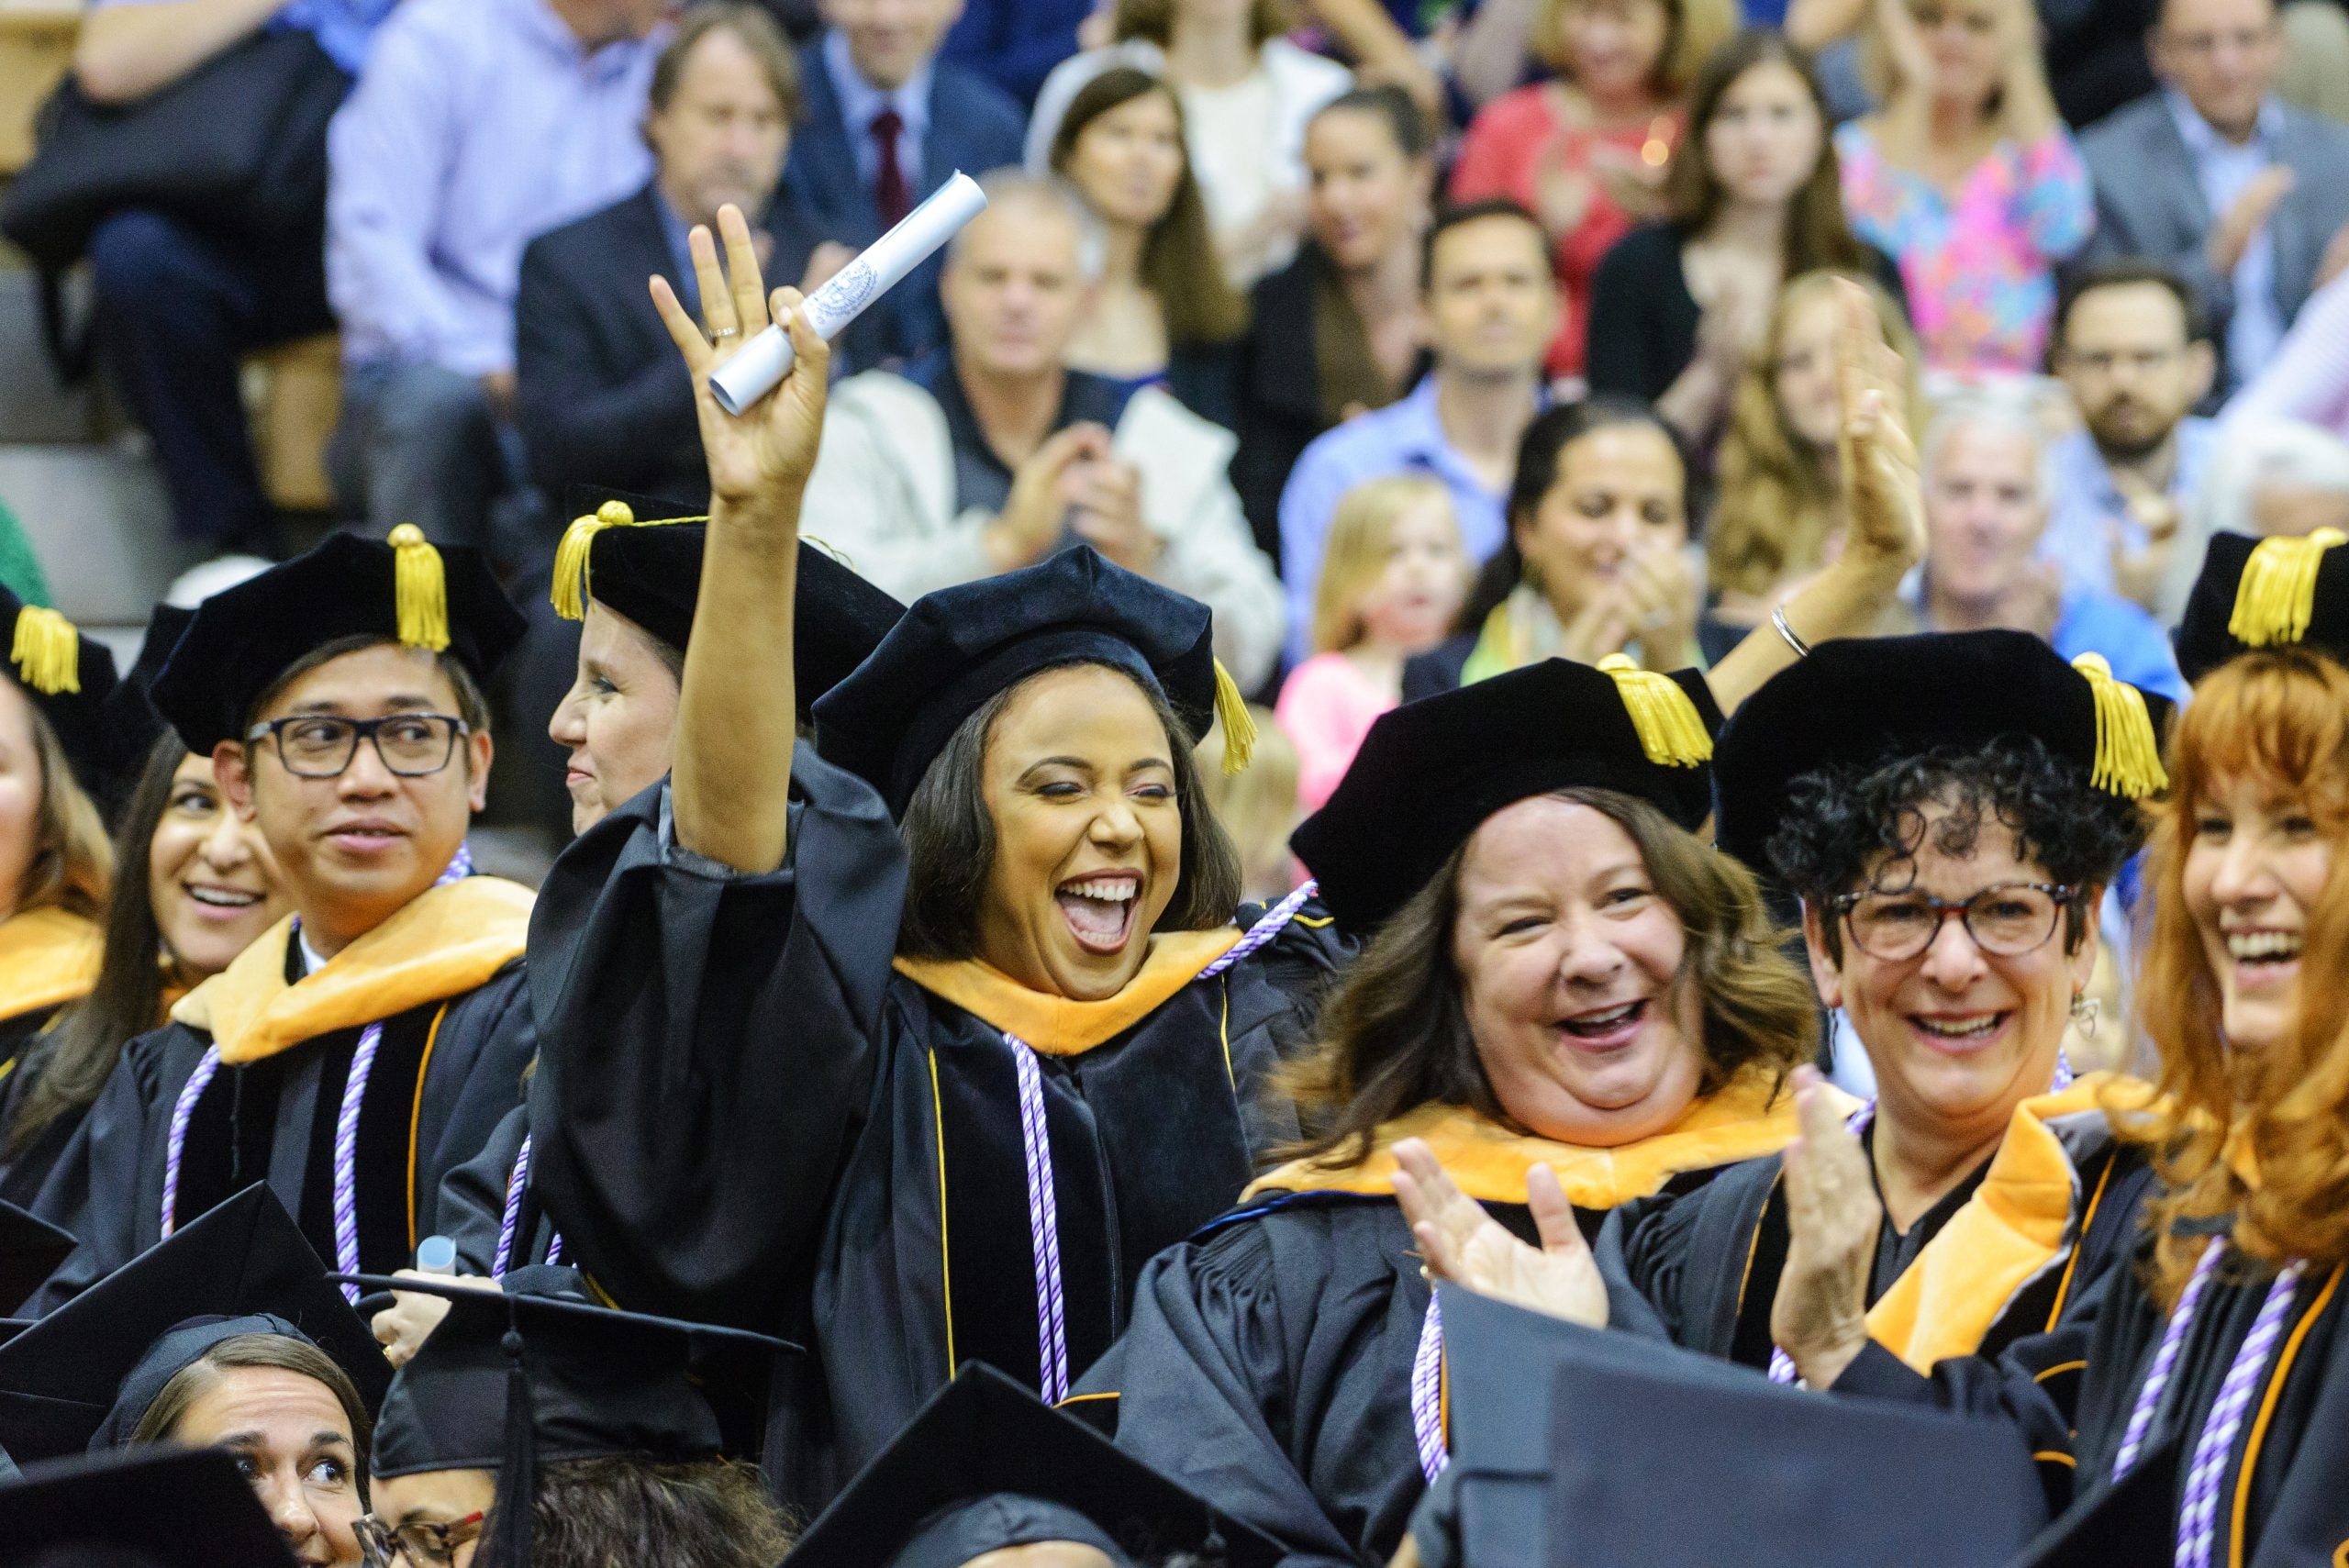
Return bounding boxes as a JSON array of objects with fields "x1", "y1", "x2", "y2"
[{"x1": 327, "y1": 0, "x2": 670, "y2": 547}]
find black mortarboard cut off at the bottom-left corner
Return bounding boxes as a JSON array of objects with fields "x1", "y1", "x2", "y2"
[{"x1": 0, "y1": 1449, "x2": 294, "y2": 1568}]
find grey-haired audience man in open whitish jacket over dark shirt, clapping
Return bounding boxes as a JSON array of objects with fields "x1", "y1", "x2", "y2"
[{"x1": 801, "y1": 173, "x2": 1283, "y2": 688}]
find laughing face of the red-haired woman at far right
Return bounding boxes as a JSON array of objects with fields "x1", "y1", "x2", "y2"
[{"x1": 2182, "y1": 774, "x2": 2332, "y2": 1051}]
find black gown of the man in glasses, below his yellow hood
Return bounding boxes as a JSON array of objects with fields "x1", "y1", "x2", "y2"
[{"x1": 30, "y1": 892, "x2": 536, "y2": 1315}]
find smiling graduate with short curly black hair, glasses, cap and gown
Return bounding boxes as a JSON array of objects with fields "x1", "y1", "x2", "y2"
[{"x1": 1598, "y1": 631, "x2": 2168, "y2": 1408}]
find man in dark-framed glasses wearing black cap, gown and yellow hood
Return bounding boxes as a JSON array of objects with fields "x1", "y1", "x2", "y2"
[{"x1": 30, "y1": 528, "x2": 536, "y2": 1312}]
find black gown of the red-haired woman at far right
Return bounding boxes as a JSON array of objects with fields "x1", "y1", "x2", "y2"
[{"x1": 1834, "y1": 1240, "x2": 2349, "y2": 1568}]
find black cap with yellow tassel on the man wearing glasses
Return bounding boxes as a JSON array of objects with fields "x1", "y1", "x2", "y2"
[{"x1": 150, "y1": 524, "x2": 524, "y2": 756}]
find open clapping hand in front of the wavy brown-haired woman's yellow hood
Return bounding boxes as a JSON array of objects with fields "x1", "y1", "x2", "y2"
[{"x1": 1396, "y1": 1139, "x2": 1607, "y2": 1329}]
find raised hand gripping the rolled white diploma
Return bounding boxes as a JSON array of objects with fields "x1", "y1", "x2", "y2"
[{"x1": 651, "y1": 202, "x2": 831, "y2": 521}]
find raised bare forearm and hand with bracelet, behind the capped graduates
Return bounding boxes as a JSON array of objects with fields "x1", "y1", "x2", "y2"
[{"x1": 1706, "y1": 282, "x2": 1924, "y2": 714}]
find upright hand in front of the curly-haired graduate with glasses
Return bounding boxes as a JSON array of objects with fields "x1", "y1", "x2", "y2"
[{"x1": 1769, "y1": 1068, "x2": 1884, "y2": 1387}]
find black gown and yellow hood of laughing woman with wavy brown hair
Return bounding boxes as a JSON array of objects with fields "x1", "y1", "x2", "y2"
[{"x1": 1078, "y1": 1089, "x2": 1795, "y2": 1568}]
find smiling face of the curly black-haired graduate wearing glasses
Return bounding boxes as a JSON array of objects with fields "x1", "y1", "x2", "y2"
[{"x1": 1802, "y1": 800, "x2": 2096, "y2": 1139}]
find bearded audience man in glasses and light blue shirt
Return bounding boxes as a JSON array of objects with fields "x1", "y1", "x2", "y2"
[{"x1": 2039, "y1": 261, "x2": 2218, "y2": 608}]
